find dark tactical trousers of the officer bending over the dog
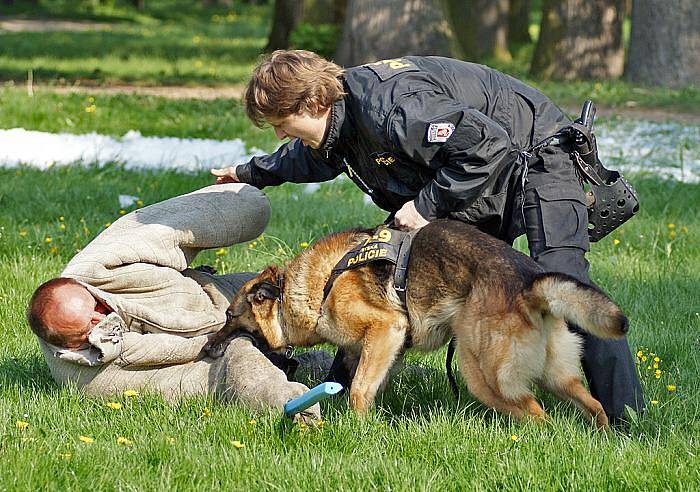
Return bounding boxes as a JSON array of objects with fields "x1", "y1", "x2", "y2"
[{"x1": 519, "y1": 146, "x2": 644, "y2": 423}]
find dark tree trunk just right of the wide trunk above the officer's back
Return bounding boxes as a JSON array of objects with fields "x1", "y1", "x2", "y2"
[{"x1": 446, "y1": 0, "x2": 510, "y2": 60}]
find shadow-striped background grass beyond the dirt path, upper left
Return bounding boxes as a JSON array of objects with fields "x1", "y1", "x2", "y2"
[{"x1": 0, "y1": 0, "x2": 270, "y2": 86}]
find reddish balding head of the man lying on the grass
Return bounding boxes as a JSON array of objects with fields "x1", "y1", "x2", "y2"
[{"x1": 27, "y1": 277, "x2": 109, "y2": 348}]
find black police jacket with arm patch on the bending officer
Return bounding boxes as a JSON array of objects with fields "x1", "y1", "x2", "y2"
[{"x1": 236, "y1": 56, "x2": 570, "y2": 236}]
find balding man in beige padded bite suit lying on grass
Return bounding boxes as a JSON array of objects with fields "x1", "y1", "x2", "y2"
[{"x1": 27, "y1": 185, "x2": 330, "y2": 417}]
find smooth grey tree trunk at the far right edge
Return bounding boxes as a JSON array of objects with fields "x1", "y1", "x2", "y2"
[{"x1": 625, "y1": 0, "x2": 700, "y2": 87}]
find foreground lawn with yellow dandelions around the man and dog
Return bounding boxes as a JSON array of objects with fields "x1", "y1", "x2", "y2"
[{"x1": 0, "y1": 166, "x2": 700, "y2": 490}]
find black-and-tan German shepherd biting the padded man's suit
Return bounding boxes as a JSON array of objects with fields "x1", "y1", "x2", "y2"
[{"x1": 205, "y1": 220, "x2": 628, "y2": 428}]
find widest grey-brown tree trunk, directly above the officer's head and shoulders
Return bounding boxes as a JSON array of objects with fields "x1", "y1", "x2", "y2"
[{"x1": 335, "y1": 0, "x2": 452, "y2": 66}]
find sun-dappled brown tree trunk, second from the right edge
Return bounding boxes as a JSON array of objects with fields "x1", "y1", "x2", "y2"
[{"x1": 530, "y1": 0, "x2": 625, "y2": 80}]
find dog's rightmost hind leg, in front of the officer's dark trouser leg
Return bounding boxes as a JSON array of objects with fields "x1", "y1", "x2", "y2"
[{"x1": 539, "y1": 316, "x2": 608, "y2": 429}]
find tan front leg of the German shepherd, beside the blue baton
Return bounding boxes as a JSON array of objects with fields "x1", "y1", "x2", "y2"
[{"x1": 350, "y1": 316, "x2": 407, "y2": 413}]
